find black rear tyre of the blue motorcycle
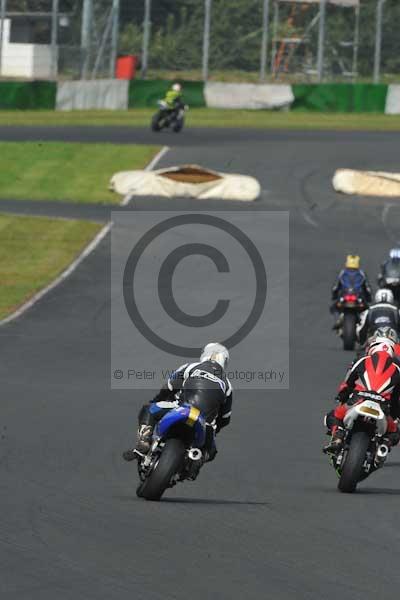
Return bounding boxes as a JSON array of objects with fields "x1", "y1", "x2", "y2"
[{"x1": 136, "y1": 439, "x2": 186, "y2": 501}]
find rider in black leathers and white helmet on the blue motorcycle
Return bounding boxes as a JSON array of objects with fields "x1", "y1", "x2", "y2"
[{"x1": 123, "y1": 342, "x2": 232, "y2": 461}]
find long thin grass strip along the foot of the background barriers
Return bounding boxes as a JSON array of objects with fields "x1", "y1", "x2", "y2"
[{"x1": 0, "y1": 108, "x2": 400, "y2": 131}]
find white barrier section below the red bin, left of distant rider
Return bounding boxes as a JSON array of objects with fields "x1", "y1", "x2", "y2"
[{"x1": 56, "y1": 79, "x2": 129, "y2": 110}]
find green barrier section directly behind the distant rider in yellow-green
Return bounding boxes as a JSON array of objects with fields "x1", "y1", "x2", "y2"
[{"x1": 128, "y1": 79, "x2": 206, "y2": 108}]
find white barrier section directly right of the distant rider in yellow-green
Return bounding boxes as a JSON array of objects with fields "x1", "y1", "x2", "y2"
[{"x1": 204, "y1": 81, "x2": 294, "y2": 109}]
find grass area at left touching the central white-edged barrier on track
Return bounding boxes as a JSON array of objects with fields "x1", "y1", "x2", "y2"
[{"x1": 0, "y1": 142, "x2": 159, "y2": 204}]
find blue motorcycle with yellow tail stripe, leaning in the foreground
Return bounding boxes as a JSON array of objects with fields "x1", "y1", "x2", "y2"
[{"x1": 136, "y1": 403, "x2": 211, "y2": 500}]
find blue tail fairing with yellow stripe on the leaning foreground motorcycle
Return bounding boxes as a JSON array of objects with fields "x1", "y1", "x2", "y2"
[{"x1": 157, "y1": 405, "x2": 206, "y2": 448}]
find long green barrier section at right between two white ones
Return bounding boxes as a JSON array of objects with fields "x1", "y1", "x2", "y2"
[{"x1": 291, "y1": 83, "x2": 388, "y2": 113}]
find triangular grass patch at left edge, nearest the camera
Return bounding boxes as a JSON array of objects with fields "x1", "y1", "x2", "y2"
[{"x1": 0, "y1": 214, "x2": 102, "y2": 319}]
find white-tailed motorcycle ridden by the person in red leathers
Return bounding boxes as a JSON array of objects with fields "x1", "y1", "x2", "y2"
[{"x1": 329, "y1": 392, "x2": 390, "y2": 493}]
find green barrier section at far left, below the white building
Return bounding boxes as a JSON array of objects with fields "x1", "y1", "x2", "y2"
[{"x1": 0, "y1": 81, "x2": 57, "y2": 110}]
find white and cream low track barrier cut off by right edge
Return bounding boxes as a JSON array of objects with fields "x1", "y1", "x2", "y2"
[{"x1": 332, "y1": 169, "x2": 400, "y2": 198}]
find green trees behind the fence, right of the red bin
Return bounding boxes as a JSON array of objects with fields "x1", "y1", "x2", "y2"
[{"x1": 121, "y1": 0, "x2": 400, "y2": 78}]
